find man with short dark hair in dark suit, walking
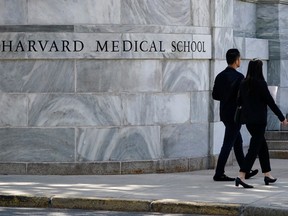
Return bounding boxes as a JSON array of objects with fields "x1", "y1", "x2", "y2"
[{"x1": 212, "y1": 49, "x2": 258, "y2": 181}]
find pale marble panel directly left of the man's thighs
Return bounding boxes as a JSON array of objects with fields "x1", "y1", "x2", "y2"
[{"x1": 210, "y1": 122, "x2": 225, "y2": 155}]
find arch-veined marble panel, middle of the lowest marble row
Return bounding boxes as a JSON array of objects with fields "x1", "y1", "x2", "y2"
[{"x1": 77, "y1": 126, "x2": 163, "y2": 161}]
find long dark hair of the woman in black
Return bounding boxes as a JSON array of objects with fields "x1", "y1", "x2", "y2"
[{"x1": 245, "y1": 59, "x2": 265, "y2": 94}]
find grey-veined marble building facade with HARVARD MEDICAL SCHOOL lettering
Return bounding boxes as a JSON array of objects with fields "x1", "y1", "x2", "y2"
[{"x1": 0, "y1": 0, "x2": 288, "y2": 174}]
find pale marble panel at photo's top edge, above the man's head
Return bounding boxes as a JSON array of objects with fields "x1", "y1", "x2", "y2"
[{"x1": 211, "y1": 0, "x2": 234, "y2": 28}]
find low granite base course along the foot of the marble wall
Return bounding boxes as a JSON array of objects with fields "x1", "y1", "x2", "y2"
[{"x1": 0, "y1": 156, "x2": 217, "y2": 175}]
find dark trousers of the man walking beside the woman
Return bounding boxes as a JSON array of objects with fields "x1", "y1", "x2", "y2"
[{"x1": 215, "y1": 122, "x2": 244, "y2": 176}]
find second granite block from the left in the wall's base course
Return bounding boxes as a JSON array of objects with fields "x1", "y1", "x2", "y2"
[{"x1": 27, "y1": 162, "x2": 120, "y2": 175}]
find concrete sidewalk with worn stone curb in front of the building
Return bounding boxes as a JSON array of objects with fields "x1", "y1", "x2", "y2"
[{"x1": 0, "y1": 159, "x2": 288, "y2": 216}]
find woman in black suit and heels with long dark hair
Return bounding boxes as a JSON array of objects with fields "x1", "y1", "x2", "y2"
[{"x1": 235, "y1": 59, "x2": 287, "y2": 188}]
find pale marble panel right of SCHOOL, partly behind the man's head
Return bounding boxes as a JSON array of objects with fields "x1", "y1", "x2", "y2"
[{"x1": 212, "y1": 28, "x2": 233, "y2": 59}]
